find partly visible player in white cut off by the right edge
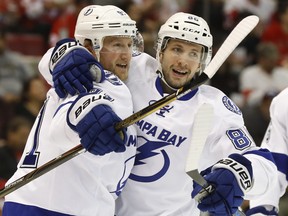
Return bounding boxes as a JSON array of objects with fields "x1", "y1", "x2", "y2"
[{"x1": 247, "y1": 88, "x2": 288, "y2": 216}]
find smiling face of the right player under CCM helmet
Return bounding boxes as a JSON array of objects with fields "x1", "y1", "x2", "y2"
[{"x1": 160, "y1": 39, "x2": 203, "y2": 89}]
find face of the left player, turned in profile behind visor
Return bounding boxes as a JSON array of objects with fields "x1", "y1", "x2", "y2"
[{"x1": 100, "y1": 36, "x2": 132, "y2": 81}]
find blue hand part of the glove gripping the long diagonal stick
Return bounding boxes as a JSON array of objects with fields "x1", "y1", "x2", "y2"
[{"x1": 76, "y1": 104, "x2": 127, "y2": 155}]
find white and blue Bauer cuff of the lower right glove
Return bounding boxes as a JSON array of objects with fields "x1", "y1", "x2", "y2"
[{"x1": 212, "y1": 154, "x2": 253, "y2": 194}]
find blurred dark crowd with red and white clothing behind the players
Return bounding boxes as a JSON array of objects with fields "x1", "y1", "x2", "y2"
[{"x1": 0, "y1": 0, "x2": 288, "y2": 216}]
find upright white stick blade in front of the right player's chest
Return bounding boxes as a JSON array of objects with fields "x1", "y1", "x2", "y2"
[{"x1": 185, "y1": 103, "x2": 244, "y2": 216}]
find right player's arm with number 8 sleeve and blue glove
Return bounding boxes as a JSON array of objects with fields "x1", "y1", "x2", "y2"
[{"x1": 192, "y1": 94, "x2": 277, "y2": 215}]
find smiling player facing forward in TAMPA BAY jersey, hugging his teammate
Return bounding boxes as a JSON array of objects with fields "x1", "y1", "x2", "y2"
[{"x1": 35, "y1": 9, "x2": 277, "y2": 216}]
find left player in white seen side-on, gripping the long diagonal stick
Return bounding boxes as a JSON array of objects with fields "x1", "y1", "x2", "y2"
[{"x1": 3, "y1": 6, "x2": 136, "y2": 216}]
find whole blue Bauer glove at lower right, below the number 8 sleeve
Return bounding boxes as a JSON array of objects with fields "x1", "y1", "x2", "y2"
[{"x1": 192, "y1": 154, "x2": 252, "y2": 216}]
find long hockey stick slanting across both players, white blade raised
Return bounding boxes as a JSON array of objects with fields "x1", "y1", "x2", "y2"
[{"x1": 0, "y1": 16, "x2": 259, "y2": 198}]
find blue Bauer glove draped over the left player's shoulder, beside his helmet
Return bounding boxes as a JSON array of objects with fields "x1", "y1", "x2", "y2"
[{"x1": 49, "y1": 39, "x2": 105, "y2": 98}]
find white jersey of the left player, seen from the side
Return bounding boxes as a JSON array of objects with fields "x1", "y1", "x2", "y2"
[{"x1": 4, "y1": 70, "x2": 136, "y2": 216}]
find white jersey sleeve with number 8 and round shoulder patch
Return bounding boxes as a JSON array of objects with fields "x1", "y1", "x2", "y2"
[{"x1": 203, "y1": 87, "x2": 277, "y2": 202}]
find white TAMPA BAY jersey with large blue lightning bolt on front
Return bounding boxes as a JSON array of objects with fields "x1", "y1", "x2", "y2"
[{"x1": 116, "y1": 54, "x2": 276, "y2": 216}]
